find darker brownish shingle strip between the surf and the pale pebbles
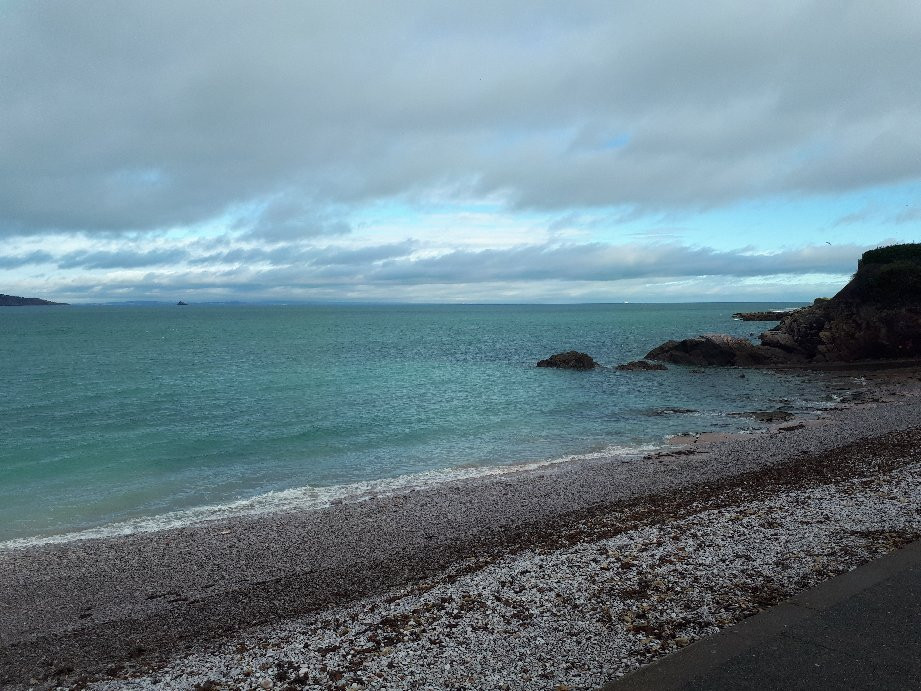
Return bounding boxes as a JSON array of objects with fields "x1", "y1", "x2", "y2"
[{"x1": 0, "y1": 372, "x2": 921, "y2": 688}]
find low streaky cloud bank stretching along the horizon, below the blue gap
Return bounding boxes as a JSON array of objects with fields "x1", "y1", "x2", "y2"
[{"x1": 6, "y1": 241, "x2": 865, "y2": 302}]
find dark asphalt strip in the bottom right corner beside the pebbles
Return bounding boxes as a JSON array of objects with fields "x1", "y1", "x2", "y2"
[{"x1": 604, "y1": 541, "x2": 921, "y2": 691}]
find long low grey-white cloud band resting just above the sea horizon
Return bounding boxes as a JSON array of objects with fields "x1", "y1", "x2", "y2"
[{"x1": 28, "y1": 243, "x2": 867, "y2": 301}]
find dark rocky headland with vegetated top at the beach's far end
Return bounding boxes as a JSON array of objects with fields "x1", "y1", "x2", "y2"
[{"x1": 645, "y1": 243, "x2": 921, "y2": 367}]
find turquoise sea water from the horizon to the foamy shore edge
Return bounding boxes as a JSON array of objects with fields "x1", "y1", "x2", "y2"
[{"x1": 0, "y1": 303, "x2": 832, "y2": 541}]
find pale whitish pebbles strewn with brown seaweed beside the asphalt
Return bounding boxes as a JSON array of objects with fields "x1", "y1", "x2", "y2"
[{"x1": 77, "y1": 382, "x2": 921, "y2": 691}]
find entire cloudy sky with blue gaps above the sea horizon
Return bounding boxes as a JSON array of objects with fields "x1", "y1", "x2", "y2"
[{"x1": 0, "y1": 0, "x2": 921, "y2": 303}]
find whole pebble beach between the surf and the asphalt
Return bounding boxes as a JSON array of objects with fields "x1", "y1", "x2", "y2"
[{"x1": 0, "y1": 369, "x2": 921, "y2": 689}]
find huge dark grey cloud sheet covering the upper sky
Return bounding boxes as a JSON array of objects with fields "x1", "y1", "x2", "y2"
[{"x1": 0, "y1": 0, "x2": 921, "y2": 241}]
